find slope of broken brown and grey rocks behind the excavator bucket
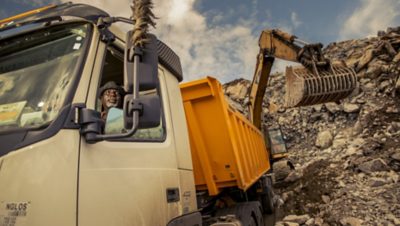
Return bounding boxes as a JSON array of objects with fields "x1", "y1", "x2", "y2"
[{"x1": 224, "y1": 27, "x2": 400, "y2": 226}]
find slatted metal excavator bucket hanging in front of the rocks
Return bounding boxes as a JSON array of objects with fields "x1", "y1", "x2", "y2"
[{"x1": 285, "y1": 64, "x2": 357, "y2": 107}]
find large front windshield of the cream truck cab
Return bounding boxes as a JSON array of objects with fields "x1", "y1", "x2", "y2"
[{"x1": 0, "y1": 24, "x2": 89, "y2": 132}]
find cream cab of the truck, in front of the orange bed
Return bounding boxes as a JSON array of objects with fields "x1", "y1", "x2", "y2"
[{"x1": 0, "y1": 3, "x2": 201, "y2": 226}]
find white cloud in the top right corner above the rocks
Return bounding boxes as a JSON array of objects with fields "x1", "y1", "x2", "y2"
[{"x1": 339, "y1": 0, "x2": 400, "y2": 39}]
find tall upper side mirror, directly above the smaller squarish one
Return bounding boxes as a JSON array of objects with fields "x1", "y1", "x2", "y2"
[{"x1": 124, "y1": 31, "x2": 158, "y2": 93}]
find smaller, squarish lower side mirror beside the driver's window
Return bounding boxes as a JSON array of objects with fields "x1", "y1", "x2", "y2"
[{"x1": 124, "y1": 94, "x2": 161, "y2": 129}]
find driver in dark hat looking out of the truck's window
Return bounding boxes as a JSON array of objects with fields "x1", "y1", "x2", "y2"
[{"x1": 100, "y1": 81, "x2": 125, "y2": 121}]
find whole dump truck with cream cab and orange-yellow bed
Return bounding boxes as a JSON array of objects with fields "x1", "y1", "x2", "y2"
[{"x1": 0, "y1": 0, "x2": 356, "y2": 226}]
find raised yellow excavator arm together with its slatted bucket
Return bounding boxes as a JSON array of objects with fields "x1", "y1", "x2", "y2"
[{"x1": 248, "y1": 29, "x2": 356, "y2": 129}]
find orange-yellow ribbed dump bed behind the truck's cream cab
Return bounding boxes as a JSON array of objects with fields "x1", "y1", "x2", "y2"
[{"x1": 180, "y1": 77, "x2": 270, "y2": 195}]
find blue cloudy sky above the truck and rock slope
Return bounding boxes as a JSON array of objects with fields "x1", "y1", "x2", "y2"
[{"x1": 0, "y1": 0, "x2": 400, "y2": 82}]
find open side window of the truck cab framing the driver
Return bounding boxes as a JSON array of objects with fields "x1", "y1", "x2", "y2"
[{"x1": 96, "y1": 46, "x2": 165, "y2": 141}]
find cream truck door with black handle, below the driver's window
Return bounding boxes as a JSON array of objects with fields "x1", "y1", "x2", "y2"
[{"x1": 78, "y1": 43, "x2": 182, "y2": 226}]
